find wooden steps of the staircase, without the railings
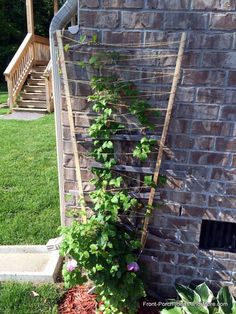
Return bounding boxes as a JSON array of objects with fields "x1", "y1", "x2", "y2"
[{"x1": 13, "y1": 66, "x2": 48, "y2": 112}]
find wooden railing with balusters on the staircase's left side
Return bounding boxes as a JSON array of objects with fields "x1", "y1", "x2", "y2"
[{"x1": 4, "y1": 33, "x2": 50, "y2": 110}]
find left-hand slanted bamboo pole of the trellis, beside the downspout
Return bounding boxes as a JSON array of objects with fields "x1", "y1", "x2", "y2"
[{"x1": 57, "y1": 31, "x2": 87, "y2": 223}]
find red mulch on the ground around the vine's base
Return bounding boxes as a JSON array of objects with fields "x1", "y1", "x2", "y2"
[{"x1": 59, "y1": 286, "x2": 159, "y2": 314}]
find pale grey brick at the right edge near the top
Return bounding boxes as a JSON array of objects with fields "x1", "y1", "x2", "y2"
[{"x1": 210, "y1": 13, "x2": 236, "y2": 31}]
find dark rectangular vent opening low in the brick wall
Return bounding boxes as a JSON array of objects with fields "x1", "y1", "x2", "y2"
[{"x1": 199, "y1": 220, "x2": 236, "y2": 252}]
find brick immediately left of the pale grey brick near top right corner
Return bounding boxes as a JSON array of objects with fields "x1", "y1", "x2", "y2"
[{"x1": 164, "y1": 12, "x2": 208, "y2": 30}]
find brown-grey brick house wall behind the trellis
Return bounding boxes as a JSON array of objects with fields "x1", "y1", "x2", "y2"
[{"x1": 60, "y1": 0, "x2": 236, "y2": 296}]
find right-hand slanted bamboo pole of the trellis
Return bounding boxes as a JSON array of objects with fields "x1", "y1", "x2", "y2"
[{"x1": 141, "y1": 32, "x2": 187, "y2": 250}]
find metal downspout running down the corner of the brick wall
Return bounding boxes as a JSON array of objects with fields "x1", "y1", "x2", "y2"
[{"x1": 49, "y1": 0, "x2": 78, "y2": 225}]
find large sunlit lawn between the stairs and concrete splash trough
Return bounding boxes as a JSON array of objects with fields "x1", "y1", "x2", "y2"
[{"x1": 0, "y1": 115, "x2": 60, "y2": 244}]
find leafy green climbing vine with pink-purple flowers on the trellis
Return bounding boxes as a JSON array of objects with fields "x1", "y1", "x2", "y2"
[{"x1": 61, "y1": 37, "x2": 165, "y2": 314}]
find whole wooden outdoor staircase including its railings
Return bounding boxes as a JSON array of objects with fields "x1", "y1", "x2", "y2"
[{"x1": 4, "y1": 33, "x2": 53, "y2": 112}]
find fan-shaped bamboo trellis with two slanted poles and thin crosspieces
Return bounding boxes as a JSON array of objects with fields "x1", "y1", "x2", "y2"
[{"x1": 57, "y1": 32, "x2": 187, "y2": 250}]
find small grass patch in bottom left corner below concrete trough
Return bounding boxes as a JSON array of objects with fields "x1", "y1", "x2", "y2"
[{"x1": 0, "y1": 282, "x2": 62, "y2": 314}]
